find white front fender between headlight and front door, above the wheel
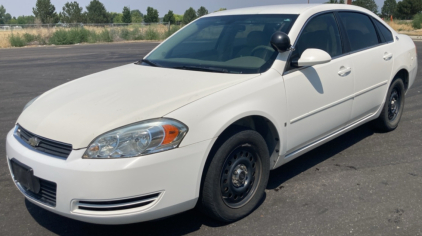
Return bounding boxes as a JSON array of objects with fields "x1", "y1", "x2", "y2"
[{"x1": 165, "y1": 69, "x2": 286, "y2": 170}]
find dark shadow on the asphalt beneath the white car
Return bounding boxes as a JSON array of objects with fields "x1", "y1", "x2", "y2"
[{"x1": 25, "y1": 122, "x2": 374, "y2": 235}]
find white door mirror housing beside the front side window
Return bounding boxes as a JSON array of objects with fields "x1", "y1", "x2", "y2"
[{"x1": 292, "y1": 48, "x2": 331, "y2": 67}]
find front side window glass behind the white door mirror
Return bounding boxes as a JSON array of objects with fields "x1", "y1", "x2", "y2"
[{"x1": 291, "y1": 13, "x2": 342, "y2": 63}]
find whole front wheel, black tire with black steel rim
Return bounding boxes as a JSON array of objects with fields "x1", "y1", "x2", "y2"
[{"x1": 199, "y1": 130, "x2": 270, "y2": 223}]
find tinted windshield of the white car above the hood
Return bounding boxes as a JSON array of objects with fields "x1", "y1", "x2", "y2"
[{"x1": 147, "y1": 15, "x2": 297, "y2": 74}]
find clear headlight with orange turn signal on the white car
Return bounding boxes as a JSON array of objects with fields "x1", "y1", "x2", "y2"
[{"x1": 83, "y1": 118, "x2": 188, "y2": 159}]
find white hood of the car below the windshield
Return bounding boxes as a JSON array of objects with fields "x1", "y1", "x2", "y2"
[{"x1": 17, "y1": 64, "x2": 257, "y2": 149}]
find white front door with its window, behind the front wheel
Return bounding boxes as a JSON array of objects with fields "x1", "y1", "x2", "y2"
[{"x1": 283, "y1": 13, "x2": 354, "y2": 154}]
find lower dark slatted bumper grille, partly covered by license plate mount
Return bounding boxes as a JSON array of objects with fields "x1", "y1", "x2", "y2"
[{"x1": 17, "y1": 178, "x2": 57, "y2": 207}]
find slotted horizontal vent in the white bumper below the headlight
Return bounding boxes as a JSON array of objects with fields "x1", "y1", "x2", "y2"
[{"x1": 75, "y1": 193, "x2": 161, "y2": 213}]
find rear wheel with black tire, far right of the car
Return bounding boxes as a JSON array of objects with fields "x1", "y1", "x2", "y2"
[{"x1": 375, "y1": 78, "x2": 405, "y2": 132}]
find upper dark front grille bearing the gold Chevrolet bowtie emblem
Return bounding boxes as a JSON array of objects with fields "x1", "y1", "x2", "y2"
[{"x1": 16, "y1": 126, "x2": 72, "y2": 159}]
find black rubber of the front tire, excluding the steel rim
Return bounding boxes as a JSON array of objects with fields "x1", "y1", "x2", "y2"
[{"x1": 201, "y1": 130, "x2": 270, "y2": 222}]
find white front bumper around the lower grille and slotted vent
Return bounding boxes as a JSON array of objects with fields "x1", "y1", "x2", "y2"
[{"x1": 6, "y1": 130, "x2": 212, "y2": 224}]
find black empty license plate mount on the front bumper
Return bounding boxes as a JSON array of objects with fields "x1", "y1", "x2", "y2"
[{"x1": 10, "y1": 158, "x2": 40, "y2": 194}]
